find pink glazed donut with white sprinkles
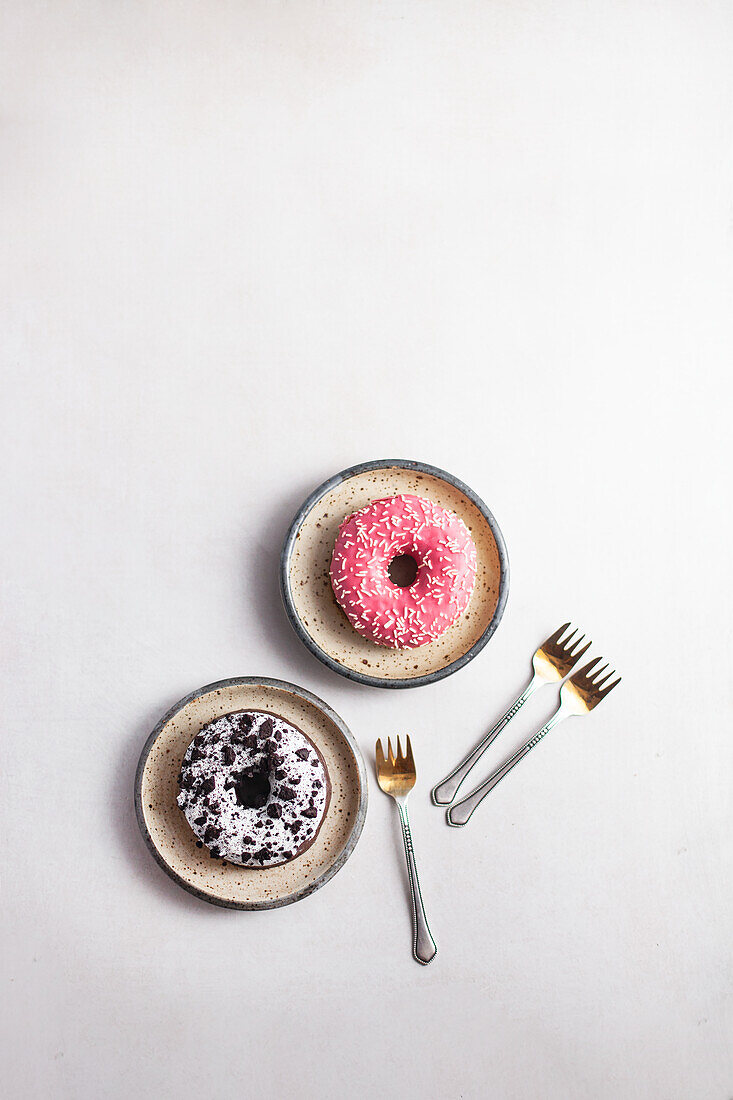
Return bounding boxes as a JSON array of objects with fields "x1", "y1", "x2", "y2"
[{"x1": 331, "y1": 493, "x2": 477, "y2": 649}]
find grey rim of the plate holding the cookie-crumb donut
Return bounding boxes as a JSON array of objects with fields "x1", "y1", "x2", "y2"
[{"x1": 133, "y1": 677, "x2": 369, "y2": 912}]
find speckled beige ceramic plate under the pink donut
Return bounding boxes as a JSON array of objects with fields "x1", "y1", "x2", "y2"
[{"x1": 281, "y1": 459, "x2": 508, "y2": 688}]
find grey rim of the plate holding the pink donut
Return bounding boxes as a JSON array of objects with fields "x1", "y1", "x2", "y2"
[{"x1": 280, "y1": 459, "x2": 510, "y2": 689}]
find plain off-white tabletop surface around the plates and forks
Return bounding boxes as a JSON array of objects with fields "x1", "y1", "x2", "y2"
[{"x1": 0, "y1": 0, "x2": 733, "y2": 1100}]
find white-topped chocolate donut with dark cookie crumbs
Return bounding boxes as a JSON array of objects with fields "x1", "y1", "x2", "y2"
[{"x1": 177, "y1": 711, "x2": 331, "y2": 867}]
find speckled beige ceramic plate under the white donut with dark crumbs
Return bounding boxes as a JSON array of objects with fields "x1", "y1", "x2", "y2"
[{"x1": 134, "y1": 677, "x2": 368, "y2": 909}]
